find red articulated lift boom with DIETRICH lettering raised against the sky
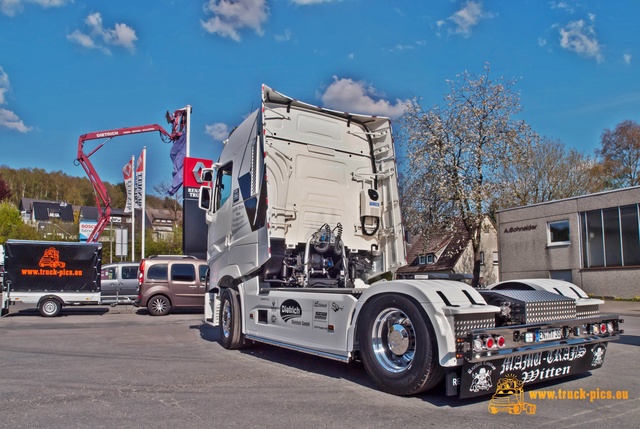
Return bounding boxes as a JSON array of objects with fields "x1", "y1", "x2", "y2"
[{"x1": 75, "y1": 108, "x2": 188, "y2": 243}]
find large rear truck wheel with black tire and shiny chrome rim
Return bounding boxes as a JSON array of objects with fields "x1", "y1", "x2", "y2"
[{"x1": 358, "y1": 294, "x2": 444, "y2": 396}]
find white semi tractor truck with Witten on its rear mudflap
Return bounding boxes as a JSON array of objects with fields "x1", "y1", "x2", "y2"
[{"x1": 199, "y1": 86, "x2": 622, "y2": 397}]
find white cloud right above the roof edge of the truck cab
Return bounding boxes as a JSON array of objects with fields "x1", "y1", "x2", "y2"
[{"x1": 321, "y1": 76, "x2": 410, "y2": 118}]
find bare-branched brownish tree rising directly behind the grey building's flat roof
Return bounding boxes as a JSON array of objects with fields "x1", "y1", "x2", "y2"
[{"x1": 493, "y1": 136, "x2": 602, "y2": 209}]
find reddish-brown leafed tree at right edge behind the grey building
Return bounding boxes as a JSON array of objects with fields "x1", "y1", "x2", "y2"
[{"x1": 596, "y1": 120, "x2": 640, "y2": 189}]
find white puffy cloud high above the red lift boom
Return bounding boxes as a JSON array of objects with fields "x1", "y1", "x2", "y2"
[{"x1": 67, "y1": 12, "x2": 138, "y2": 54}]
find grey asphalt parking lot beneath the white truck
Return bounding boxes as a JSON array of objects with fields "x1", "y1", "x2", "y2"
[{"x1": 0, "y1": 302, "x2": 640, "y2": 429}]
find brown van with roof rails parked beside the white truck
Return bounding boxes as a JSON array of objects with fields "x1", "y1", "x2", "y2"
[{"x1": 135, "y1": 255, "x2": 209, "y2": 316}]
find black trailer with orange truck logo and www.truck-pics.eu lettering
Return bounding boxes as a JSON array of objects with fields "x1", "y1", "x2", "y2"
[{"x1": 0, "y1": 240, "x2": 102, "y2": 317}]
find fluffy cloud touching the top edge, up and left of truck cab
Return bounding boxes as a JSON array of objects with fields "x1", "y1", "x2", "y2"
[{"x1": 200, "y1": 0, "x2": 269, "y2": 42}]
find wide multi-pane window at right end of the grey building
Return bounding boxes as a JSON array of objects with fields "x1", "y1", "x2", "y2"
[{"x1": 580, "y1": 204, "x2": 640, "y2": 268}]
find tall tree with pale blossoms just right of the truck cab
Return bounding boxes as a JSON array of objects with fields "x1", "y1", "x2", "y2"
[{"x1": 400, "y1": 64, "x2": 532, "y2": 286}]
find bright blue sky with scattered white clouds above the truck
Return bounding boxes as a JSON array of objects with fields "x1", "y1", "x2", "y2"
[{"x1": 0, "y1": 0, "x2": 640, "y2": 191}]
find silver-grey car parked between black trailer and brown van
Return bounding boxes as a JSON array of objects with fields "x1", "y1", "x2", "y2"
[{"x1": 100, "y1": 262, "x2": 140, "y2": 304}]
